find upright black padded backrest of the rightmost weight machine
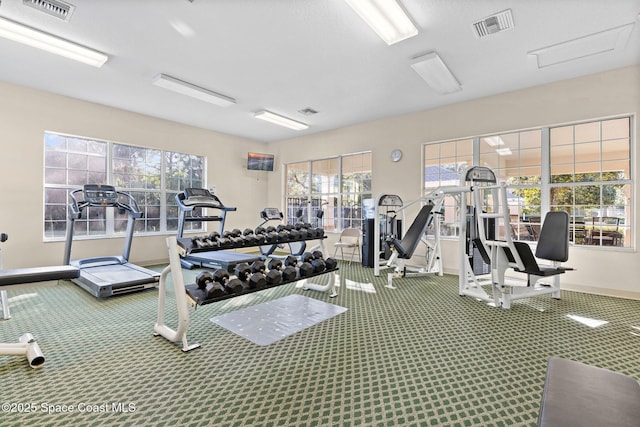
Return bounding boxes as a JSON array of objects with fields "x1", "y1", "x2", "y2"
[{"x1": 536, "y1": 211, "x2": 569, "y2": 262}]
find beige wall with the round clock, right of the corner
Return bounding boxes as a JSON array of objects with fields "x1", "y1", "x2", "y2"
[{"x1": 268, "y1": 66, "x2": 640, "y2": 297}]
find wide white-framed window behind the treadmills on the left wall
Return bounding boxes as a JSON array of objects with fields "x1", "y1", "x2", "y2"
[{"x1": 44, "y1": 133, "x2": 205, "y2": 240}]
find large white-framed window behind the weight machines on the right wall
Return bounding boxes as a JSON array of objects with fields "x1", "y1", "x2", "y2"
[{"x1": 424, "y1": 116, "x2": 633, "y2": 247}]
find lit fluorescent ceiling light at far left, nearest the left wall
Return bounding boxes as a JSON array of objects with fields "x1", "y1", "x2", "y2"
[{"x1": 0, "y1": 17, "x2": 109, "y2": 68}]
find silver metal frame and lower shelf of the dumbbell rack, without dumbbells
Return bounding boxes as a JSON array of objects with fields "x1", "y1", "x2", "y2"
[{"x1": 153, "y1": 237, "x2": 338, "y2": 352}]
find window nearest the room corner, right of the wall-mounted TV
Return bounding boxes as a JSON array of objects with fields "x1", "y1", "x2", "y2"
[{"x1": 286, "y1": 152, "x2": 371, "y2": 230}]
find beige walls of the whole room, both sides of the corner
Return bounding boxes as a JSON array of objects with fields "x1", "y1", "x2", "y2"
[{"x1": 0, "y1": 66, "x2": 640, "y2": 296}]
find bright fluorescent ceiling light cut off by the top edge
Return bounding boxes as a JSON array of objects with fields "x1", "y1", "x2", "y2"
[{"x1": 345, "y1": 0, "x2": 418, "y2": 45}]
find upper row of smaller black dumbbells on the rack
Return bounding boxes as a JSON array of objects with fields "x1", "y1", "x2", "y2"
[{"x1": 186, "y1": 225, "x2": 324, "y2": 250}]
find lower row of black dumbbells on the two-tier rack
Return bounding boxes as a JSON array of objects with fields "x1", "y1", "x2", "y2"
[{"x1": 188, "y1": 251, "x2": 338, "y2": 303}]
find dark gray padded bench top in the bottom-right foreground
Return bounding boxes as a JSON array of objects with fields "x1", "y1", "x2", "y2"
[{"x1": 538, "y1": 357, "x2": 640, "y2": 427}]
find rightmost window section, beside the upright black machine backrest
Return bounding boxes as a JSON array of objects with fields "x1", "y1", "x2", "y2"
[{"x1": 549, "y1": 117, "x2": 632, "y2": 247}]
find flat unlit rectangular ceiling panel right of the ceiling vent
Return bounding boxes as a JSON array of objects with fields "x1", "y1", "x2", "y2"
[{"x1": 529, "y1": 23, "x2": 635, "y2": 68}]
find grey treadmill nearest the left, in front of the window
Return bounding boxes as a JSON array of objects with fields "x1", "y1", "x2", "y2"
[{"x1": 64, "y1": 184, "x2": 160, "y2": 298}]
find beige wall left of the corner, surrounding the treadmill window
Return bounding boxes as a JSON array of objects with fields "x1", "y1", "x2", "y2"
[{"x1": 0, "y1": 82, "x2": 269, "y2": 268}]
